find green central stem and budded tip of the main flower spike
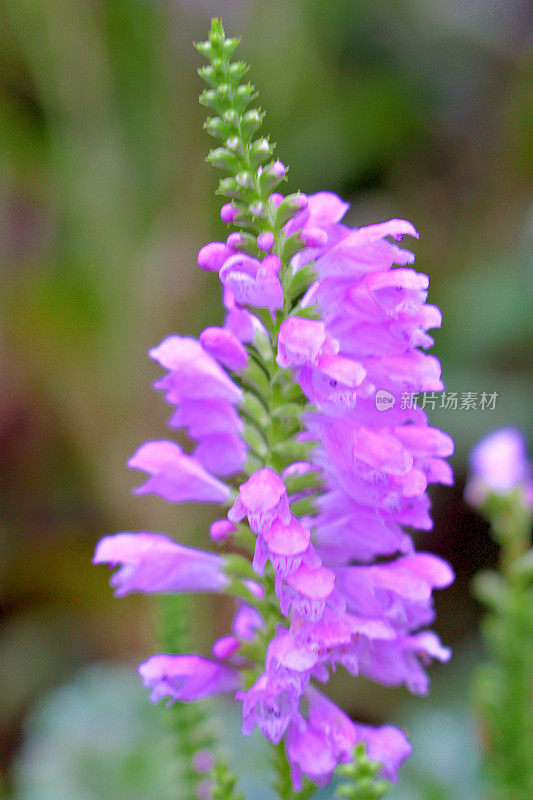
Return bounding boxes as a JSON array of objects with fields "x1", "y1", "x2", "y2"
[{"x1": 196, "y1": 19, "x2": 320, "y2": 800}]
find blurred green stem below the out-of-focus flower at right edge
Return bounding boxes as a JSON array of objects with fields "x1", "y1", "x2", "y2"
[{"x1": 474, "y1": 491, "x2": 533, "y2": 800}]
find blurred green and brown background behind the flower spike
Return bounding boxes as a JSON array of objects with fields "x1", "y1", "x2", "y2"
[{"x1": 0, "y1": 0, "x2": 533, "y2": 800}]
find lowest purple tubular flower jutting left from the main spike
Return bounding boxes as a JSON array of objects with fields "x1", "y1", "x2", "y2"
[{"x1": 139, "y1": 654, "x2": 240, "y2": 705}]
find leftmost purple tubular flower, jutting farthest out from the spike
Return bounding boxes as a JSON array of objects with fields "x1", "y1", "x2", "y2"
[{"x1": 93, "y1": 532, "x2": 229, "y2": 597}]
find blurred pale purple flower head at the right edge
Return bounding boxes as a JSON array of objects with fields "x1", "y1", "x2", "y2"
[{"x1": 466, "y1": 428, "x2": 532, "y2": 506}]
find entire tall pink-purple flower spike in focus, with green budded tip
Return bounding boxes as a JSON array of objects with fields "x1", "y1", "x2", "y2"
[{"x1": 95, "y1": 20, "x2": 453, "y2": 791}]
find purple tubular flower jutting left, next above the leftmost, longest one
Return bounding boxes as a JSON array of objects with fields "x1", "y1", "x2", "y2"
[{"x1": 128, "y1": 441, "x2": 231, "y2": 503}]
